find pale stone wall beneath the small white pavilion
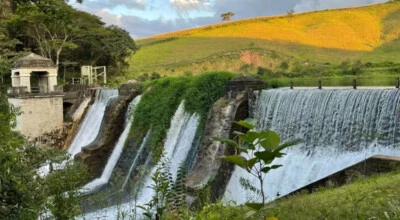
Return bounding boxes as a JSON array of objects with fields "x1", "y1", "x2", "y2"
[{"x1": 8, "y1": 96, "x2": 64, "y2": 139}]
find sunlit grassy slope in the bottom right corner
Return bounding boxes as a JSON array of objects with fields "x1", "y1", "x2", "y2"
[{"x1": 264, "y1": 172, "x2": 400, "y2": 219}]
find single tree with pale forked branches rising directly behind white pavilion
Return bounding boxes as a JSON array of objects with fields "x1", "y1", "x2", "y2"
[{"x1": 12, "y1": 0, "x2": 82, "y2": 67}]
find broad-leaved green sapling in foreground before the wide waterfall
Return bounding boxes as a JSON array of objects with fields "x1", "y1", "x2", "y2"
[{"x1": 212, "y1": 119, "x2": 299, "y2": 204}]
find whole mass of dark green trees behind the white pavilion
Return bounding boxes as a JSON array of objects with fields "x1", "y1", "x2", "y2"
[{"x1": 0, "y1": 0, "x2": 137, "y2": 84}]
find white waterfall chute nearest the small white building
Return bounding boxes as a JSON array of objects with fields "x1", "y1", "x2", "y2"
[{"x1": 68, "y1": 89, "x2": 118, "y2": 157}]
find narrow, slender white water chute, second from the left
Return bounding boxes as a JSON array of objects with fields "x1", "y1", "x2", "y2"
[{"x1": 81, "y1": 96, "x2": 142, "y2": 193}]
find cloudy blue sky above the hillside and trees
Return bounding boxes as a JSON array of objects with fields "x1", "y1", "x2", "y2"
[{"x1": 69, "y1": 0, "x2": 388, "y2": 39}]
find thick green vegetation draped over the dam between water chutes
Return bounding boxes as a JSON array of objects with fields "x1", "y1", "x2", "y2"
[{"x1": 131, "y1": 72, "x2": 235, "y2": 158}]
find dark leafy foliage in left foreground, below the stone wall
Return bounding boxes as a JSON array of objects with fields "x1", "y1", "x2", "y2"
[{"x1": 0, "y1": 93, "x2": 87, "y2": 219}]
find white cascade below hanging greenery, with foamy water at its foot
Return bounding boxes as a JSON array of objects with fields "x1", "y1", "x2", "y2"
[{"x1": 81, "y1": 102, "x2": 199, "y2": 219}]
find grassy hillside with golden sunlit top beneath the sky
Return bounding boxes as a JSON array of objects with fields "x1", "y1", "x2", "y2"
[{"x1": 128, "y1": 2, "x2": 400, "y2": 81}]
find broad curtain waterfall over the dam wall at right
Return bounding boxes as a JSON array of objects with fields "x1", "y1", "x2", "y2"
[{"x1": 224, "y1": 89, "x2": 400, "y2": 204}]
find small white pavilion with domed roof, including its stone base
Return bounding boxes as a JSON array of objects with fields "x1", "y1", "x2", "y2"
[{"x1": 8, "y1": 53, "x2": 64, "y2": 138}]
